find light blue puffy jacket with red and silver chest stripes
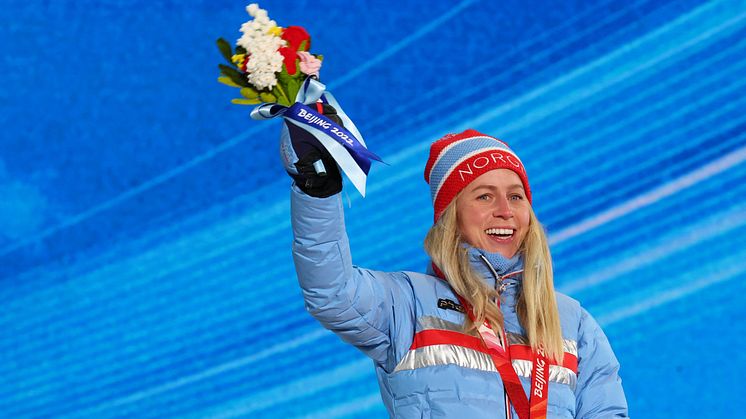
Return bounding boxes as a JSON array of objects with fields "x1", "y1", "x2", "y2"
[{"x1": 291, "y1": 186, "x2": 627, "y2": 419}]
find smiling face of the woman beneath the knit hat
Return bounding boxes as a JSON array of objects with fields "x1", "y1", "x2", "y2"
[{"x1": 456, "y1": 169, "x2": 530, "y2": 258}]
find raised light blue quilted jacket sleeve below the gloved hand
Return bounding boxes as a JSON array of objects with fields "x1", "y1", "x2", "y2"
[{"x1": 290, "y1": 186, "x2": 414, "y2": 368}]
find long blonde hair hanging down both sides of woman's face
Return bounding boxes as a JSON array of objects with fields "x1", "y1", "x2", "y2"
[{"x1": 425, "y1": 199, "x2": 564, "y2": 362}]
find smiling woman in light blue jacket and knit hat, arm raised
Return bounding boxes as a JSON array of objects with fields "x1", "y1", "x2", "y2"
[{"x1": 283, "y1": 127, "x2": 627, "y2": 419}]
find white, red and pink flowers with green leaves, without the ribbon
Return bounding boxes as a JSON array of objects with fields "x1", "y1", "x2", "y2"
[{"x1": 217, "y1": 4, "x2": 323, "y2": 106}]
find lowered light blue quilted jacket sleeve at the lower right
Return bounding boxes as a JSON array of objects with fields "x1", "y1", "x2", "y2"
[{"x1": 575, "y1": 309, "x2": 629, "y2": 418}]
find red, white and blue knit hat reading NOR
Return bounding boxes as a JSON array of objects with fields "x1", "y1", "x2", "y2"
[{"x1": 425, "y1": 129, "x2": 531, "y2": 222}]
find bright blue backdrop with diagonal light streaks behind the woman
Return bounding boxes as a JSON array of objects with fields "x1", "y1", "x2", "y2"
[{"x1": 0, "y1": 0, "x2": 746, "y2": 418}]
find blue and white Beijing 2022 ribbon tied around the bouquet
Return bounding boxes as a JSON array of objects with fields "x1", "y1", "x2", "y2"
[{"x1": 251, "y1": 77, "x2": 382, "y2": 196}]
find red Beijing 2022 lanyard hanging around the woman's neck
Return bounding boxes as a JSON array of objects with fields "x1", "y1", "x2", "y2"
[{"x1": 457, "y1": 295, "x2": 549, "y2": 419}]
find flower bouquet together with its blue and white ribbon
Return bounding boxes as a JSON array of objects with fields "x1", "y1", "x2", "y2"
[{"x1": 217, "y1": 4, "x2": 381, "y2": 196}]
